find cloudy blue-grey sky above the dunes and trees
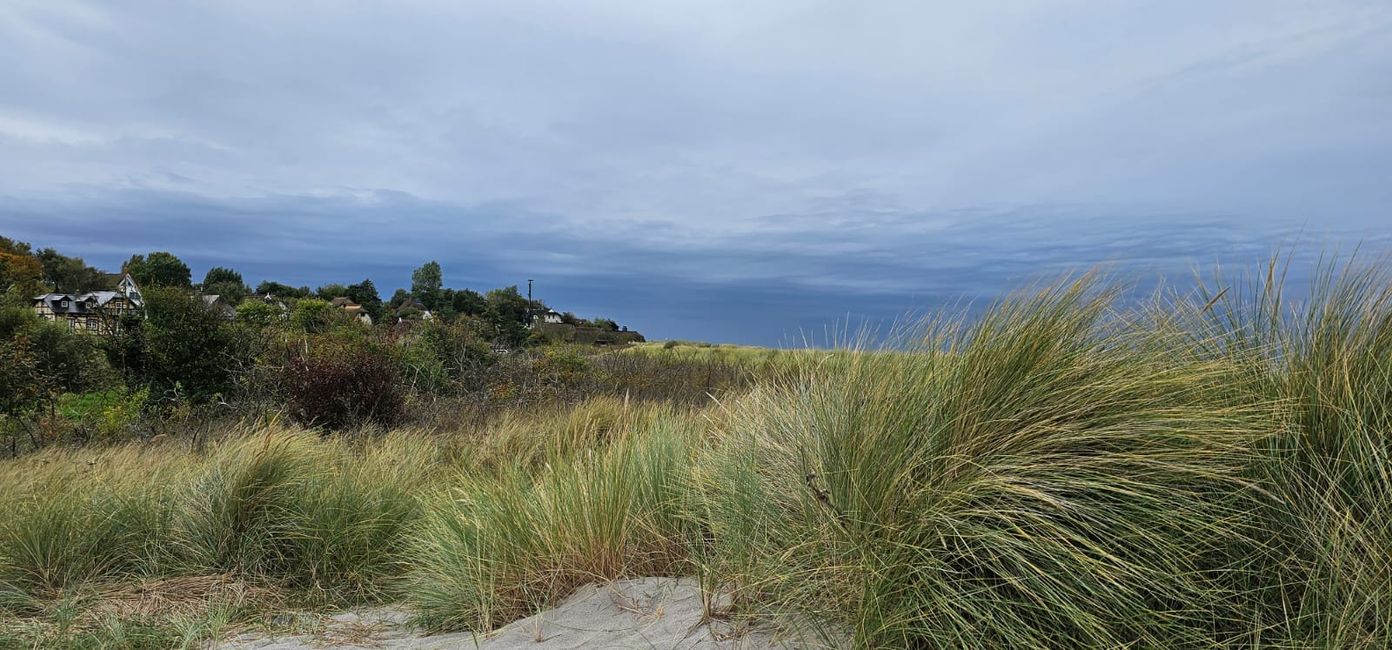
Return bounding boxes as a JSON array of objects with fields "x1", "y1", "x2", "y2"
[{"x1": 0, "y1": 0, "x2": 1392, "y2": 345}]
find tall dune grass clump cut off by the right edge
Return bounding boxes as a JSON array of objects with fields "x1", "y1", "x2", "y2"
[{"x1": 1172, "y1": 259, "x2": 1392, "y2": 647}]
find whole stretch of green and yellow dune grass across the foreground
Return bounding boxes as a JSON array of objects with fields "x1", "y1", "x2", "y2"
[{"x1": 0, "y1": 264, "x2": 1392, "y2": 647}]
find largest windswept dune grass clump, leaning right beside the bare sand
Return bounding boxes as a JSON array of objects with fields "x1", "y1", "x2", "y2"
[{"x1": 703, "y1": 276, "x2": 1267, "y2": 647}]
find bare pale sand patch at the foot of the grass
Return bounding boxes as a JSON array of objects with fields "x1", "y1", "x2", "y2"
[{"x1": 213, "y1": 578, "x2": 839, "y2": 650}]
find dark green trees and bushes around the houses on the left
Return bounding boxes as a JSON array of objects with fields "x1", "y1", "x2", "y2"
[{"x1": 0, "y1": 237, "x2": 634, "y2": 447}]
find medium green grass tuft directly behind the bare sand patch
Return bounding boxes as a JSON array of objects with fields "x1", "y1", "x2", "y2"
[{"x1": 408, "y1": 418, "x2": 695, "y2": 631}]
